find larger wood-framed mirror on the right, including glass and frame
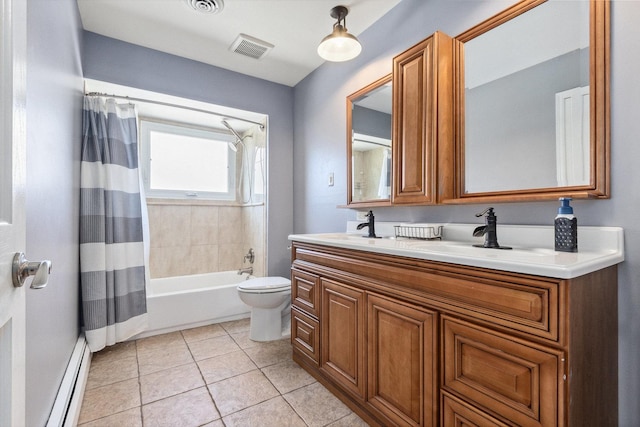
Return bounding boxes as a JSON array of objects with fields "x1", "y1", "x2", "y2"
[{"x1": 456, "y1": 0, "x2": 610, "y2": 202}]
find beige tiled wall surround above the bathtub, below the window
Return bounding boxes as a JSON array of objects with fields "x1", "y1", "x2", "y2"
[{"x1": 147, "y1": 199, "x2": 265, "y2": 278}]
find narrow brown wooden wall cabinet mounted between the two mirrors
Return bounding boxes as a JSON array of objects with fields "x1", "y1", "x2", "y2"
[{"x1": 391, "y1": 32, "x2": 458, "y2": 205}]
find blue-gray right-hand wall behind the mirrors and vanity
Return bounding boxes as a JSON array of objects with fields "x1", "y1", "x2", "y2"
[{"x1": 294, "y1": 0, "x2": 640, "y2": 427}]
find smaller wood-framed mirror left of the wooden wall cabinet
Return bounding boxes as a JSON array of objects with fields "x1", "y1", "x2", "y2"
[{"x1": 347, "y1": 75, "x2": 392, "y2": 206}]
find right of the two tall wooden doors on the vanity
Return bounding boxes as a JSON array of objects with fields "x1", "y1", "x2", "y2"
[{"x1": 367, "y1": 295, "x2": 438, "y2": 426}]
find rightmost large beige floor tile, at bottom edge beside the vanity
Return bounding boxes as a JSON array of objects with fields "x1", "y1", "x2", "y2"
[{"x1": 283, "y1": 382, "x2": 351, "y2": 427}]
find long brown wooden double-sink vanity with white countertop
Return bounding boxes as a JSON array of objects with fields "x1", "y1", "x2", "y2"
[{"x1": 290, "y1": 225, "x2": 624, "y2": 426}]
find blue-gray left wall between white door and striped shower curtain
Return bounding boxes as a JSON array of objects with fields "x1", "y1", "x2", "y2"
[{"x1": 26, "y1": 0, "x2": 83, "y2": 426}]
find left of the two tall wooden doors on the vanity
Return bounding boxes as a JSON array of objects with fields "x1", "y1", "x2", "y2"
[{"x1": 320, "y1": 278, "x2": 365, "y2": 399}]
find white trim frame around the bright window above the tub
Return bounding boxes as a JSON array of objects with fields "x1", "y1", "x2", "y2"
[{"x1": 138, "y1": 118, "x2": 237, "y2": 201}]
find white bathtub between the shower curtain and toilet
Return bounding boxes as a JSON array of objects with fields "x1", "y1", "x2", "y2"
[{"x1": 135, "y1": 270, "x2": 251, "y2": 339}]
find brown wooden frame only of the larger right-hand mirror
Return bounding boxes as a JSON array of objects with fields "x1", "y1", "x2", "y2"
[{"x1": 452, "y1": 0, "x2": 611, "y2": 203}]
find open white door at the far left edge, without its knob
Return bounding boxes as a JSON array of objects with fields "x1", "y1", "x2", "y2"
[{"x1": 0, "y1": 0, "x2": 27, "y2": 427}]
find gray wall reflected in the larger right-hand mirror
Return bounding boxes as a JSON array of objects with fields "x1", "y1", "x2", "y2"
[{"x1": 464, "y1": 49, "x2": 589, "y2": 193}]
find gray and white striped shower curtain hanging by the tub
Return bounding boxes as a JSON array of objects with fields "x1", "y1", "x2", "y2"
[{"x1": 80, "y1": 96, "x2": 149, "y2": 352}]
